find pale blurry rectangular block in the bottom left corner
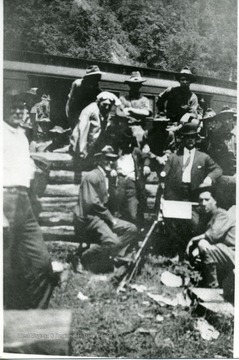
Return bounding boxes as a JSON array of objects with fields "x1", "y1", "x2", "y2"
[{"x1": 4, "y1": 309, "x2": 72, "y2": 356}]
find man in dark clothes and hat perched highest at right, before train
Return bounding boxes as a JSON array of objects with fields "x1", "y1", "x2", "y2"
[{"x1": 157, "y1": 66, "x2": 200, "y2": 123}]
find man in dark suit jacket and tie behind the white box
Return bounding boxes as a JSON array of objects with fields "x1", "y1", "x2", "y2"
[{"x1": 161, "y1": 123, "x2": 222, "y2": 255}]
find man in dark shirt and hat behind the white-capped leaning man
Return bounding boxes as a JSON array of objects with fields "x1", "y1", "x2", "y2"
[{"x1": 66, "y1": 65, "x2": 103, "y2": 129}]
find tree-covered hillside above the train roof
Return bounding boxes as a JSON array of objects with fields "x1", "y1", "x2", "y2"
[{"x1": 4, "y1": 0, "x2": 237, "y2": 80}]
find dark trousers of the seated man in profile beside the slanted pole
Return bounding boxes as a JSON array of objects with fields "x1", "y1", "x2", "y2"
[{"x1": 76, "y1": 216, "x2": 137, "y2": 273}]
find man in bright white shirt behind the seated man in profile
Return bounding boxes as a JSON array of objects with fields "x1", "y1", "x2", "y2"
[{"x1": 116, "y1": 128, "x2": 150, "y2": 228}]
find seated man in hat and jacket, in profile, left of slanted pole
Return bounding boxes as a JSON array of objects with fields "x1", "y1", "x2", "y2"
[{"x1": 74, "y1": 146, "x2": 137, "y2": 273}]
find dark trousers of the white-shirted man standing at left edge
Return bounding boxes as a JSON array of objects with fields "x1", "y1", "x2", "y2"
[{"x1": 3, "y1": 187, "x2": 55, "y2": 309}]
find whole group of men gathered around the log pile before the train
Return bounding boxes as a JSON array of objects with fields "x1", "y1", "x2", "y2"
[{"x1": 4, "y1": 65, "x2": 236, "y2": 308}]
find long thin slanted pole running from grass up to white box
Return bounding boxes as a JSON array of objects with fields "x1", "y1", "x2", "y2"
[{"x1": 117, "y1": 210, "x2": 163, "y2": 293}]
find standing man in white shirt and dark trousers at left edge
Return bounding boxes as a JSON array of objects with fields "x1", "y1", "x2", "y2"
[{"x1": 3, "y1": 94, "x2": 56, "y2": 309}]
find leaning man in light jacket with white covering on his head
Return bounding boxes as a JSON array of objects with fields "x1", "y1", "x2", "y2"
[{"x1": 70, "y1": 91, "x2": 120, "y2": 184}]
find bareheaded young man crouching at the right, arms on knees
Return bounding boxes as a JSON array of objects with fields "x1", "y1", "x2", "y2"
[{"x1": 186, "y1": 185, "x2": 236, "y2": 288}]
